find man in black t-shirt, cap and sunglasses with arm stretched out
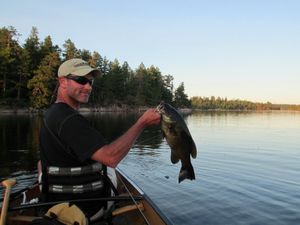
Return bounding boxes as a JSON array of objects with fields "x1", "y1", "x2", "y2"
[{"x1": 40, "y1": 59, "x2": 160, "y2": 220}]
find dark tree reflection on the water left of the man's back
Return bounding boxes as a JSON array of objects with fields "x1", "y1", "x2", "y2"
[{"x1": 0, "y1": 115, "x2": 41, "y2": 177}]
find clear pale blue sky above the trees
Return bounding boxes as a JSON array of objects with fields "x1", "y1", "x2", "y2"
[{"x1": 0, "y1": 0, "x2": 300, "y2": 104}]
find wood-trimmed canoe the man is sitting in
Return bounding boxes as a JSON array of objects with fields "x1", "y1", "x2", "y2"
[{"x1": 0, "y1": 169, "x2": 171, "y2": 225}]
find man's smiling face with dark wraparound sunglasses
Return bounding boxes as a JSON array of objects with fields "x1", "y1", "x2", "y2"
[{"x1": 66, "y1": 74, "x2": 94, "y2": 103}]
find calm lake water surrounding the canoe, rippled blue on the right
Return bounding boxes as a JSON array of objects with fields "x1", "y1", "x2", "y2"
[{"x1": 0, "y1": 112, "x2": 300, "y2": 225}]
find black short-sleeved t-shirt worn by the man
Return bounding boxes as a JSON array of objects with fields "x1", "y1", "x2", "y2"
[{"x1": 40, "y1": 103, "x2": 106, "y2": 168}]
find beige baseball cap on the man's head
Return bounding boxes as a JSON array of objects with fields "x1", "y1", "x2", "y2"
[{"x1": 58, "y1": 58, "x2": 101, "y2": 77}]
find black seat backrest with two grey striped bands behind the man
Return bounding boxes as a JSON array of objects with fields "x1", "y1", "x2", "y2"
[{"x1": 41, "y1": 162, "x2": 115, "y2": 221}]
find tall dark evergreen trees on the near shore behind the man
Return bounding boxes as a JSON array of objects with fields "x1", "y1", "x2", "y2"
[{"x1": 0, "y1": 26, "x2": 191, "y2": 109}]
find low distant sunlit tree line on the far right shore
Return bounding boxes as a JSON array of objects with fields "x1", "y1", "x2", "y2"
[{"x1": 191, "y1": 96, "x2": 300, "y2": 111}]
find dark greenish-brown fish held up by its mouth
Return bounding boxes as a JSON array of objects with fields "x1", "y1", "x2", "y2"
[{"x1": 156, "y1": 102, "x2": 197, "y2": 183}]
